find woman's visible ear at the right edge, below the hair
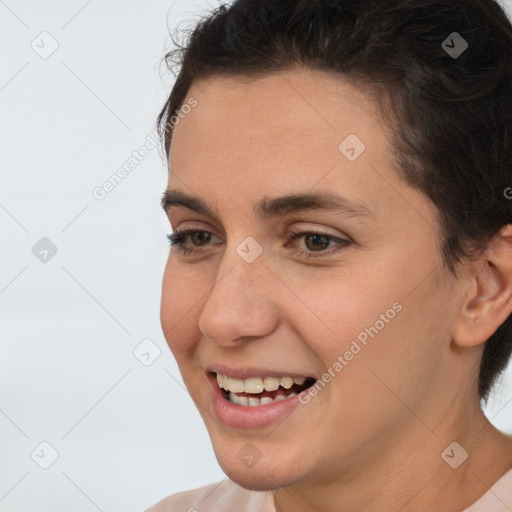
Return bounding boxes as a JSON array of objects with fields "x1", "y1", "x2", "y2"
[{"x1": 453, "y1": 224, "x2": 512, "y2": 347}]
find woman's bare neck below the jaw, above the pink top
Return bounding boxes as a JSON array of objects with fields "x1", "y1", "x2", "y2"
[{"x1": 274, "y1": 407, "x2": 512, "y2": 512}]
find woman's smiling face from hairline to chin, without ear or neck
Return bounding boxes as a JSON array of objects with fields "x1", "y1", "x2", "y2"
[{"x1": 161, "y1": 70, "x2": 467, "y2": 489}]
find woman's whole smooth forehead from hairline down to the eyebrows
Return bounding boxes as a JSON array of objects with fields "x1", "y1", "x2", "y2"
[{"x1": 169, "y1": 69, "x2": 436, "y2": 226}]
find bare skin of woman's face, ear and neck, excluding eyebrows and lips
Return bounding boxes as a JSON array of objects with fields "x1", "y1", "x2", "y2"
[{"x1": 161, "y1": 69, "x2": 512, "y2": 512}]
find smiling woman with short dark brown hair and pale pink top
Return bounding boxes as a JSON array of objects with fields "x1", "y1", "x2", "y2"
[{"x1": 149, "y1": 0, "x2": 512, "y2": 512}]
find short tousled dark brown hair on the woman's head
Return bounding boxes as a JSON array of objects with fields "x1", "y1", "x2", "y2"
[{"x1": 158, "y1": 0, "x2": 512, "y2": 401}]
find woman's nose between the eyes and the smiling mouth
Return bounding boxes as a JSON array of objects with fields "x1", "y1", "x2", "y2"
[{"x1": 199, "y1": 249, "x2": 282, "y2": 347}]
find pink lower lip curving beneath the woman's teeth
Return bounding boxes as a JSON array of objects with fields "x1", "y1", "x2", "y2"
[{"x1": 206, "y1": 370, "x2": 307, "y2": 429}]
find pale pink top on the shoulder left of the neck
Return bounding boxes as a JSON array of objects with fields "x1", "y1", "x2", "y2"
[{"x1": 144, "y1": 479, "x2": 275, "y2": 512}]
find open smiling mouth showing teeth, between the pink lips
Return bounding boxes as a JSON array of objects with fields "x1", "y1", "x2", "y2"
[{"x1": 215, "y1": 373, "x2": 316, "y2": 407}]
